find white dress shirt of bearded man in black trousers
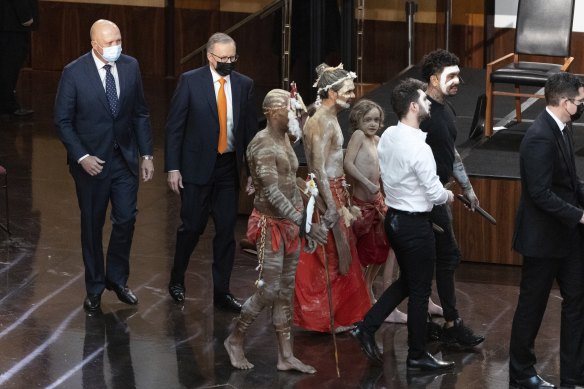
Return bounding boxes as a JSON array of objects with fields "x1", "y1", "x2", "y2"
[{"x1": 377, "y1": 122, "x2": 448, "y2": 212}]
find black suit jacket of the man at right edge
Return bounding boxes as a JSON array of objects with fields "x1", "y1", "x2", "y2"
[{"x1": 513, "y1": 111, "x2": 584, "y2": 258}]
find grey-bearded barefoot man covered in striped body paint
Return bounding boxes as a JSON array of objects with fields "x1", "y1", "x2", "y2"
[{"x1": 224, "y1": 89, "x2": 326, "y2": 373}]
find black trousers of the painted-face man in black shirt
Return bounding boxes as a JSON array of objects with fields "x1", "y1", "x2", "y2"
[{"x1": 430, "y1": 204, "x2": 460, "y2": 321}]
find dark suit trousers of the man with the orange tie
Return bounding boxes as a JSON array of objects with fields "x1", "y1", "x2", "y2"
[{"x1": 170, "y1": 153, "x2": 239, "y2": 295}]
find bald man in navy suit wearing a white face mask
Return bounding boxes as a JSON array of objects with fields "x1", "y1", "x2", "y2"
[{"x1": 55, "y1": 20, "x2": 154, "y2": 311}]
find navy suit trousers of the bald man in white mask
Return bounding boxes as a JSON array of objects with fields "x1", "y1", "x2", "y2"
[{"x1": 70, "y1": 151, "x2": 138, "y2": 294}]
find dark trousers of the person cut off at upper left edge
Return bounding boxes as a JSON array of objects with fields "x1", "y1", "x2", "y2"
[{"x1": 0, "y1": 31, "x2": 30, "y2": 114}]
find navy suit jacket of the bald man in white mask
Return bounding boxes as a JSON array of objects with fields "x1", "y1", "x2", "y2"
[{"x1": 55, "y1": 52, "x2": 152, "y2": 179}]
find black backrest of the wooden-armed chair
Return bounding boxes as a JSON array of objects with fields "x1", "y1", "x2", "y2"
[{"x1": 515, "y1": 0, "x2": 575, "y2": 57}]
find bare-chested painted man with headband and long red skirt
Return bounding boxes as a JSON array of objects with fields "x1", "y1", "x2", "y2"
[{"x1": 294, "y1": 64, "x2": 371, "y2": 332}]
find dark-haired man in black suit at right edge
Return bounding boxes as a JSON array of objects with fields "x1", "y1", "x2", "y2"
[{"x1": 509, "y1": 73, "x2": 584, "y2": 389}]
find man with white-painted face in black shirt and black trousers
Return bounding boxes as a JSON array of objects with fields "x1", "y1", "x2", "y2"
[{"x1": 420, "y1": 49, "x2": 485, "y2": 347}]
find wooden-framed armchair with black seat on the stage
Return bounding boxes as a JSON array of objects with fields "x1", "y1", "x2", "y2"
[{"x1": 485, "y1": 0, "x2": 574, "y2": 137}]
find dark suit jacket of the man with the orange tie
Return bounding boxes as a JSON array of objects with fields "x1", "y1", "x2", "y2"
[{"x1": 165, "y1": 66, "x2": 258, "y2": 185}]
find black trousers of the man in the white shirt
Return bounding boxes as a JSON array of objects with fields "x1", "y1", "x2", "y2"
[{"x1": 362, "y1": 209, "x2": 436, "y2": 359}]
